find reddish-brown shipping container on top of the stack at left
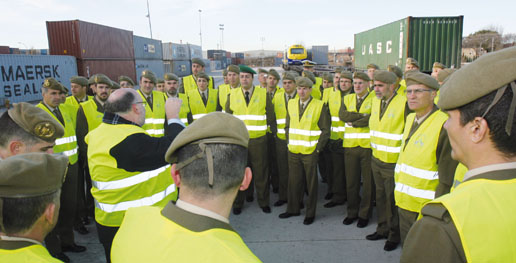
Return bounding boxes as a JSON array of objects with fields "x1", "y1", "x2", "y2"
[{"x1": 47, "y1": 20, "x2": 134, "y2": 60}]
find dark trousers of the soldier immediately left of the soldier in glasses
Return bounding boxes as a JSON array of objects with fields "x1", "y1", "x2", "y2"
[{"x1": 371, "y1": 157, "x2": 400, "y2": 243}]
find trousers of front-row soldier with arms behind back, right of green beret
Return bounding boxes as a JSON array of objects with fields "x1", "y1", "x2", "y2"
[{"x1": 287, "y1": 151, "x2": 319, "y2": 218}]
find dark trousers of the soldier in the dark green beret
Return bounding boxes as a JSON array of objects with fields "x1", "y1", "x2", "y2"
[{"x1": 233, "y1": 135, "x2": 270, "y2": 208}]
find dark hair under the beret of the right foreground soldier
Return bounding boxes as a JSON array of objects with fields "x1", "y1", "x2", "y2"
[{"x1": 457, "y1": 80, "x2": 516, "y2": 157}]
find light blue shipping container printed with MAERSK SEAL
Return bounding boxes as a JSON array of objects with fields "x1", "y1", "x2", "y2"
[{"x1": 0, "y1": 55, "x2": 77, "y2": 105}]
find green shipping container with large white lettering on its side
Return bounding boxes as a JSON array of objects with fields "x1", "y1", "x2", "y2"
[{"x1": 355, "y1": 16, "x2": 464, "y2": 72}]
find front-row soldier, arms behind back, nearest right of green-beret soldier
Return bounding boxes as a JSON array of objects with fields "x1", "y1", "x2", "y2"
[{"x1": 279, "y1": 77, "x2": 330, "y2": 225}]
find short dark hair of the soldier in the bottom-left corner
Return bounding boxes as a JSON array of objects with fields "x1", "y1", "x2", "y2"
[{"x1": 2, "y1": 190, "x2": 61, "y2": 235}]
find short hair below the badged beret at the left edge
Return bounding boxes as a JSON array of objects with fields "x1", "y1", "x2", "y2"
[{"x1": 0, "y1": 111, "x2": 41, "y2": 147}]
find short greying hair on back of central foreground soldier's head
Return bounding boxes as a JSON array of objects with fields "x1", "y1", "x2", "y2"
[{"x1": 177, "y1": 143, "x2": 247, "y2": 197}]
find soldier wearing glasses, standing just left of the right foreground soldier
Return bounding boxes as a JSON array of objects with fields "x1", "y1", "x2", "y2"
[{"x1": 394, "y1": 71, "x2": 457, "y2": 245}]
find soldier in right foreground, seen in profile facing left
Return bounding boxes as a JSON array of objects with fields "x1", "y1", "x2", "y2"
[{"x1": 401, "y1": 47, "x2": 516, "y2": 263}]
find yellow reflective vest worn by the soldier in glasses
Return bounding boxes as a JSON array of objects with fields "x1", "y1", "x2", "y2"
[{"x1": 394, "y1": 111, "x2": 448, "y2": 213}]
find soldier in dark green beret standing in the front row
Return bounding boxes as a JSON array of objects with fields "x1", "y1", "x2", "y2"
[{"x1": 225, "y1": 65, "x2": 276, "y2": 215}]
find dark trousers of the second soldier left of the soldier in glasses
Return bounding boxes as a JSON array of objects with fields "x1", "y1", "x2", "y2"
[{"x1": 344, "y1": 147, "x2": 374, "y2": 219}]
